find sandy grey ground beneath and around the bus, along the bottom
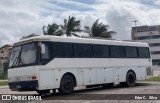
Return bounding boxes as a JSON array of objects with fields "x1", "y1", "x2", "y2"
[{"x1": 0, "y1": 82, "x2": 160, "y2": 103}]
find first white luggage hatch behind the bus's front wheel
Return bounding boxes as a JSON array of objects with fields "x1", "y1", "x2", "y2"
[{"x1": 83, "y1": 68, "x2": 97, "y2": 85}]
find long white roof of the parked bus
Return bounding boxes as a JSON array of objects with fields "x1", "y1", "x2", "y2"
[{"x1": 14, "y1": 35, "x2": 149, "y2": 47}]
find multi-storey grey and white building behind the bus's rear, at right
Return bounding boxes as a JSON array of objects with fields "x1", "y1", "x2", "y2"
[{"x1": 131, "y1": 25, "x2": 160, "y2": 66}]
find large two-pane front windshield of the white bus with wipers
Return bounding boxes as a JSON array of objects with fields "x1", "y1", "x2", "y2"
[{"x1": 9, "y1": 42, "x2": 37, "y2": 67}]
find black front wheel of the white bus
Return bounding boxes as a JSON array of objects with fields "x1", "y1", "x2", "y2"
[{"x1": 58, "y1": 74, "x2": 75, "y2": 94}]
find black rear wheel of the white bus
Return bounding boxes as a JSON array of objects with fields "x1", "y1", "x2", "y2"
[{"x1": 121, "y1": 71, "x2": 136, "y2": 87}]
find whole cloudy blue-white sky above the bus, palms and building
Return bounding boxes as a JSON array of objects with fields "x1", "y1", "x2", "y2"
[{"x1": 0, "y1": 0, "x2": 160, "y2": 46}]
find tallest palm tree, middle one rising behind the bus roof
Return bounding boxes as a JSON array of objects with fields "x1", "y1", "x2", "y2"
[{"x1": 61, "y1": 16, "x2": 82, "y2": 37}]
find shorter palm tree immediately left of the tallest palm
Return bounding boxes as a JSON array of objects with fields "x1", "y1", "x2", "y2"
[{"x1": 42, "y1": 23, "x2": 63, "y2": 36}]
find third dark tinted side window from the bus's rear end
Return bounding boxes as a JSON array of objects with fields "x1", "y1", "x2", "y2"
[{"x1": 110, "y1": 46, "x2": 124, "y2": 58}]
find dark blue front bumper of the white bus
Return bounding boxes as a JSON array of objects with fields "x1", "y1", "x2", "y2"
[{"x1": 8, "y1": 80, "x2": 38, "y2": 91}]
